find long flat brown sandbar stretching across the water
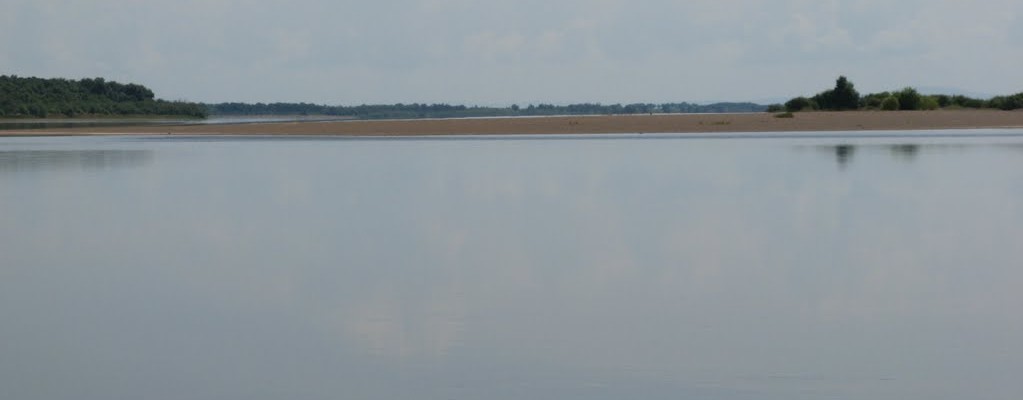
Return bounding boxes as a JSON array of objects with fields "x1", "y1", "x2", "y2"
[{"x1": 0, "y1": 109, "x2": 1023, "y2": 136}]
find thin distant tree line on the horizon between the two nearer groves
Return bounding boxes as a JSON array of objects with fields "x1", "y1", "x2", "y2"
[{"x1": 207, "y1": 102, "x2": 766, "y2": 120}]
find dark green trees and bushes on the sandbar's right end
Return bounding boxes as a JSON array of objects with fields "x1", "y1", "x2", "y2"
[{"x1": 767, "y1": 77, "x2": 1023, "y2": 113}]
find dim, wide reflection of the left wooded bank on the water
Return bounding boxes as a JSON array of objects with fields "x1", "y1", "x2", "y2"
[{"x1": 0, "y1": 149, "x2": 152, "y2": 173}]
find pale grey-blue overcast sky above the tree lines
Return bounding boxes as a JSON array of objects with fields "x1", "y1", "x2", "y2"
[{"x1": 0, "y1": 0, "x2": 1023, "y2": 105}]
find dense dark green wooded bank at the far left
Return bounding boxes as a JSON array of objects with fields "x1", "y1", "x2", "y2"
[{"x1": 0, "y1": 76, "x2": 207, "y2": 118}]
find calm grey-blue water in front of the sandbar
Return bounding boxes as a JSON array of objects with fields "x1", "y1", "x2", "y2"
[{"x1": 0, "y1": 131, "x2": 1023, "y2": 400}]
